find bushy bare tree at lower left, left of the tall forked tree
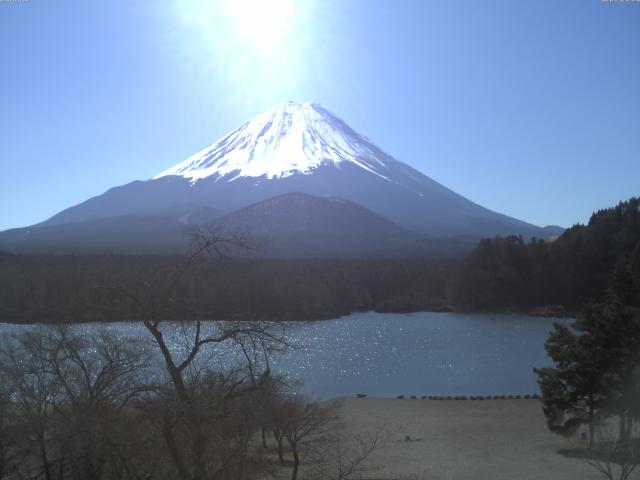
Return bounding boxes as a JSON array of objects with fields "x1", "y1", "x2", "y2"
[{"x1": 37, "y1": 328, "x2": 147, "y2": 480}]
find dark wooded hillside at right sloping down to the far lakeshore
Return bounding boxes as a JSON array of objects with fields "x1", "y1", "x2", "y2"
[{"x1": 453, "y1": 198, "x2": 640, "y2": 310}]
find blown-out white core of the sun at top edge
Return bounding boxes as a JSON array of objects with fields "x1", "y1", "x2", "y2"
[{"x1": 221, "y1": 0, "x2": 296, "y2": 53}]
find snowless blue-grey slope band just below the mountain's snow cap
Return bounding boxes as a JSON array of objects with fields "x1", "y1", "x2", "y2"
[{"x1": 43, "y1": 165, "x2": 548, "y2": 238}]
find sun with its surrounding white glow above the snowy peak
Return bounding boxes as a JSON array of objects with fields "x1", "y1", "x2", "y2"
[{"x1": 171, "y1": 0, "x2": 334, "y2": 108}]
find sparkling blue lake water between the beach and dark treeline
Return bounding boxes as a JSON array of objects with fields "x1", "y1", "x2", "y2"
[{"x1": 1, "y1": 312, "x2": 555, "y2": 398}]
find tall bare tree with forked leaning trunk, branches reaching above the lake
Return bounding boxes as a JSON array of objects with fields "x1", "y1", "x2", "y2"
[{"x1": 111, "y1": 228, "x2": 286, "y2": 480}]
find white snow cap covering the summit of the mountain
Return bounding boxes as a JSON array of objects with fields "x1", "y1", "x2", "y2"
[{"x1": 154, "y1": 102, "x2": 387, "y2": 181}]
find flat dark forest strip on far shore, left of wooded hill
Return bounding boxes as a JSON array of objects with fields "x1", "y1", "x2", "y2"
[{"x1": 0, "y1": 255, "x2": 450, "y2": 323}]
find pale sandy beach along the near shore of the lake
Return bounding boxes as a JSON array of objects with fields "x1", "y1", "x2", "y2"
[{"x1": 341, "y1": 398, "x2": 608, "y2": 480}]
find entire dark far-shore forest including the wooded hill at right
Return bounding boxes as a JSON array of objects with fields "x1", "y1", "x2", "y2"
[{"x1": 0, "y1": 198, "x2": 640, "y2": 322}]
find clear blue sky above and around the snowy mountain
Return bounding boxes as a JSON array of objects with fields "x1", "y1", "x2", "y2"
[{"x1": 0, "y1": 0, "x2": 640, "y2": 229}]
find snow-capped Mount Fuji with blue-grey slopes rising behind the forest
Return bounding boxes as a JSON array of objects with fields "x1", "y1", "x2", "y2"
[{"x1": 0, "y1": 102, "x2": 548, "y2": 254}]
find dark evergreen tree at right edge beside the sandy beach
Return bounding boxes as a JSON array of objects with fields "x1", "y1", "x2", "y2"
[{"x1": 535, "y1": 256, "x2": 640, "y2": 448}]
